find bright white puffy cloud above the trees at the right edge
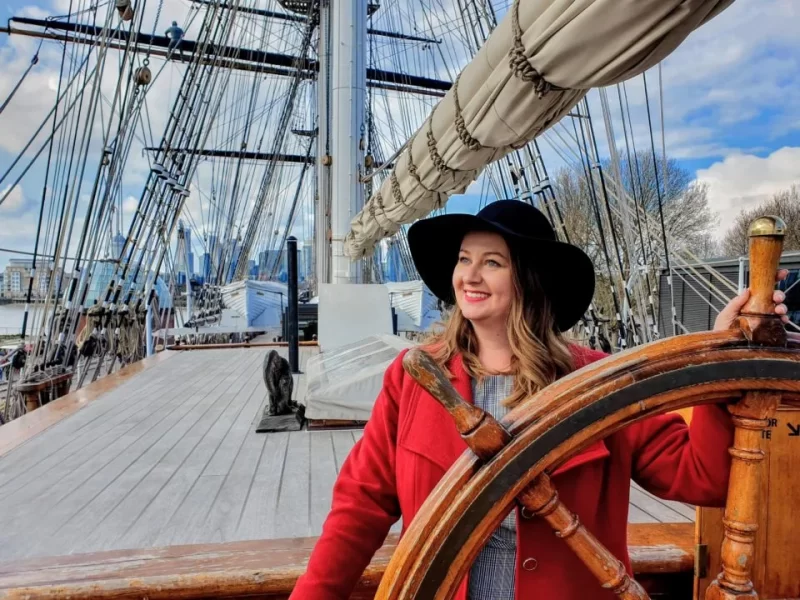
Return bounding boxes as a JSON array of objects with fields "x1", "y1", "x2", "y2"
[{"x1": 697, "y1": 147, "x2": 800, "y2": 235}]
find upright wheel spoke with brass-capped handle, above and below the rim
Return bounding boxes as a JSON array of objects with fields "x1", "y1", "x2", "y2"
[{"x1": 705, "y1": 217, "x2": 787, "y2": 600}]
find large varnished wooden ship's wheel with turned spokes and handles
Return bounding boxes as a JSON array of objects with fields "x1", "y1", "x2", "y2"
[{"x1": 376, "y1": 217, "x2": 800, "y2": 600}]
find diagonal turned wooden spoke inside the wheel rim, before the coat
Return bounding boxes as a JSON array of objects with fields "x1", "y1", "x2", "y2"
[{"x1": 517, "y1": 473, "x2": 649, "y2": 600}]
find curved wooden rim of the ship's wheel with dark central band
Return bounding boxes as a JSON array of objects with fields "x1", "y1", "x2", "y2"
[{"x1": 376, "y1": 330, "x2": 800, "y2": 600}]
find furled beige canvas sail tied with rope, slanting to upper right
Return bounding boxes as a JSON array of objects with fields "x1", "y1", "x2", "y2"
[{"x1": 345, "y1": 0, "x2": 733, "y2": 259}]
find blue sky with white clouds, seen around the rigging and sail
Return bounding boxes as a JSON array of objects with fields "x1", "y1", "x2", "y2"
[{"x1": 0, "y1": 0, "x2": 800, "y2": 269}]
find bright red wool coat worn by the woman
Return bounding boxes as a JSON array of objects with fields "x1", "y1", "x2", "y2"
[{"x1": 291, "y1": 346, "x2": 733, "y2": 600}]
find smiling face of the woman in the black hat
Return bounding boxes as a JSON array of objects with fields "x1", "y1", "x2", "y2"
[{"x1": 453, "y1": 231, "x2": 514, "y2": 324}]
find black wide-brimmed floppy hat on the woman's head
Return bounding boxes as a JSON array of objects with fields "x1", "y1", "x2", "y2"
[{"x1": 408, "y1": 200, "x2": 595, "y2": 331}]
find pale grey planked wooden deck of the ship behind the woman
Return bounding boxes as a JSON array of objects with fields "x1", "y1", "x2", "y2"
[{"x1": 0, "y1": 347, "x2": 694, "y2": 561}]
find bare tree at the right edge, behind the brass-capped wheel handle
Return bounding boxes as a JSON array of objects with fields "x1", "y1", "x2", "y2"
[{"x1": 722, "y1": 185, "x2": 800, "y2": 256}]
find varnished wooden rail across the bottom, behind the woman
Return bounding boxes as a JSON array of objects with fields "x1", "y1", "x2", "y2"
[{"x1": 0, "y1": 523, "x2": 694, "y2": 600}]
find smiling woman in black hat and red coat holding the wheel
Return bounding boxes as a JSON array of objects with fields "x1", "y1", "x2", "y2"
[{"x1": 291, "y1": 200, "x2": 786, "y2": 600}]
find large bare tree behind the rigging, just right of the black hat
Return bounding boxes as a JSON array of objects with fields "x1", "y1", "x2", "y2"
[{"x1": 545, "y1": 152, "x2": 718, "y2": 340}]
